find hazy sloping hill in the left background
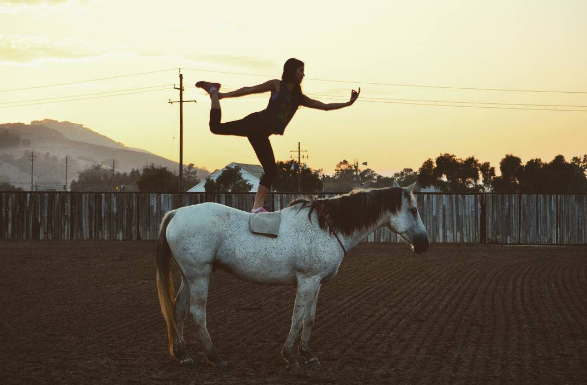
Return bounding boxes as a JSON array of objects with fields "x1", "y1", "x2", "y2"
[{"x1": 0, "y1": 119, "x2": 210, "y2": 190}]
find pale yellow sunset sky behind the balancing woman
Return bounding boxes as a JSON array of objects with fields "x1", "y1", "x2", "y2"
[{"x1": 0, "y1": 0, "x2": 587, "y2": 175}]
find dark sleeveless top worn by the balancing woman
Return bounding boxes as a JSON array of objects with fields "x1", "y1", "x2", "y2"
[{"x1": 262, "y1": 81, "x2": 300, "y2": 135}]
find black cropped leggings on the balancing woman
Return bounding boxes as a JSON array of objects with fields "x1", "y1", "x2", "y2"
[{"x1": 210, "y1": 108, "x2": 277, "y2": 190}]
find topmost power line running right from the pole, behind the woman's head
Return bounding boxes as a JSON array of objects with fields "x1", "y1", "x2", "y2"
[{"x1": 184, "y1": 68, "x2": 587, "y2": 94}]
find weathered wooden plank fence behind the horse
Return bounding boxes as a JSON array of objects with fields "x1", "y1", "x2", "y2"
[{"x1": 0, "y1": 192, "x2": 587, "y2": 245}]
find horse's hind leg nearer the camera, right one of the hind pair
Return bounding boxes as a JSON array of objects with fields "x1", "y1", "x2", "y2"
[{"x1": 190, "y1": 267, "x2": 226, "y2": 367}]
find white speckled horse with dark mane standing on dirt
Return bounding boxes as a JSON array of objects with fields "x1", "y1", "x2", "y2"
[{"x1": 157, "y1": 184, "x2": 428, "y2": 370}]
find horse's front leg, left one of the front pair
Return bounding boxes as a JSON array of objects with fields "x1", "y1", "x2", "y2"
[{"x1": 282, "y1": 277, "x2": 320, "y2": 370}]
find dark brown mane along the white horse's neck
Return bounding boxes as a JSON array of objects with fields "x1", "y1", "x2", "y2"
[{"x1": 287, "y1": 187, "x2": 404, "y2": 235}]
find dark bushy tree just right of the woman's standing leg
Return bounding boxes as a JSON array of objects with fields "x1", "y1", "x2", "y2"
[{"x1": 272, "y1": 160, "x2": 322, "y2": 192}]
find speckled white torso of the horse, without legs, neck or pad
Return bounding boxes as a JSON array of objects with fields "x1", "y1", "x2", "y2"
[{"x1": 167, "y1": 203, "x2": 340, "y2": 284}]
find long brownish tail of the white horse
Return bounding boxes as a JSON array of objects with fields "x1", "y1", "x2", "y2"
[{"x1": 157, "y1": 211, "x2": 181, "y2": 356}]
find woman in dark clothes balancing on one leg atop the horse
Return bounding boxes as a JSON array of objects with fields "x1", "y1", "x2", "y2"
[{"x1": 196, "y1": 58, "x2": 361, "y2": 214}]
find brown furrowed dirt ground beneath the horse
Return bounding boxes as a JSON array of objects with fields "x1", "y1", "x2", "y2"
[{"x1": 0, "y1": 241, "x2": 587, "y2": 384}]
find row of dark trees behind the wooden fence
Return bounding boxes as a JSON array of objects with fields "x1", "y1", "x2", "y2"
[{"x1": 0, "y1": 153, "x2": 587, "y2": 190}]
